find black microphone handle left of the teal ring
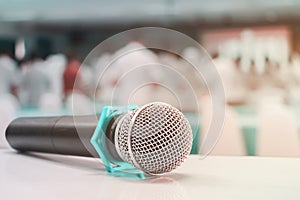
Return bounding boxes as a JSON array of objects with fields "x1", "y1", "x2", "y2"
[{"x1": 6, "y1": 115, "x2": 99, "y2": 157}]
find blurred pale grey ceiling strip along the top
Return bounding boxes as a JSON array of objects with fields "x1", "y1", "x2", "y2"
[{"x1": 0, "y1": 0, "x2": 300, "y2": 25}]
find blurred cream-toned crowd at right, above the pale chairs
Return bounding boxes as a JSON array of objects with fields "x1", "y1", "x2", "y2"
[{"x1": 214, "y1": 51, "x2": 300, "y2": 105}]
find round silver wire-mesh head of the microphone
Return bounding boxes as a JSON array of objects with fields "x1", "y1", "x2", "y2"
[{"x1": 117, "y1": 102, "x2": 193, "y2": 174}]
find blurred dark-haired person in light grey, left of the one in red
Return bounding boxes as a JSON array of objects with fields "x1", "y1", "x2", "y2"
[{"x1": 19, "y1": 53, "x2": 50, "y2": 106}]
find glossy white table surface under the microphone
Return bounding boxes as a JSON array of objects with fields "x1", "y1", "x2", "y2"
[{"x1": 0, "y1": 149, "x2": 300, "y2": 200}]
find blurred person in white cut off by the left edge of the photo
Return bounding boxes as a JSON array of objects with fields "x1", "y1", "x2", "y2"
[{"x1": 0, "y1": 52, "x2": 17, "y2": 95}]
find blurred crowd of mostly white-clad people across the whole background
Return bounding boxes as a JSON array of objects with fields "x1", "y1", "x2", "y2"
[{"x1": 0, "y1": 42, "x2": 300, "y2": 111}]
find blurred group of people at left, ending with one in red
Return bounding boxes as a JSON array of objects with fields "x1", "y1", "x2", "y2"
[{"x1": 0, "y1": 50, "x2": 87, "y2": 107}]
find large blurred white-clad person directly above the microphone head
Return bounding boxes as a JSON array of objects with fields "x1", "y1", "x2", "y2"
[{"x1": 105, "y1": 42, "x2": 163, "y2": 105}]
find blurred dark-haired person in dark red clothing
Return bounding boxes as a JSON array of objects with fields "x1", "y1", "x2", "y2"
[{"x1": 63, "y1": 52, "x2": 80, "y2": 99}]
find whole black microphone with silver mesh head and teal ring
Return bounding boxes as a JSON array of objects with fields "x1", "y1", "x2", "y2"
[{"x1": 6, "y1": 102, "x2": 193, "y2": 175}]
